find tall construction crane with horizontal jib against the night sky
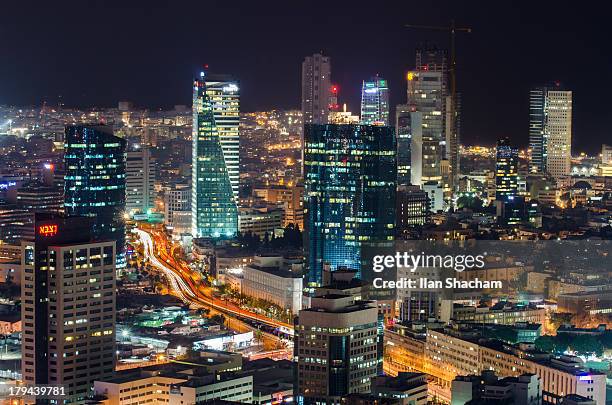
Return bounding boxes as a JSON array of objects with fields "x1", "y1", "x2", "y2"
[{"x1": 404, "y1": 20, "x2": 472, "y2": 187}]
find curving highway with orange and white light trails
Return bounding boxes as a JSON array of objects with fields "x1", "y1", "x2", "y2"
[{"x1": 134, "y1": 229, "x2": 293, "y2": 355}]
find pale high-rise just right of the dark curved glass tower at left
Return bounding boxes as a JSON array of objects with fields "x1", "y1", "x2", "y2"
[{"x1": 125, "y1": 144, "x2": 155, "y2": 215}]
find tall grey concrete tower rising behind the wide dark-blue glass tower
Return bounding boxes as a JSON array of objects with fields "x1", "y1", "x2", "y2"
[{"x1": 302, "y1": 53, "x2": 332, "y2": 124}]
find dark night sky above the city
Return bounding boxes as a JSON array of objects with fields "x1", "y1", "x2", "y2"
[{"x1": 0, "y1": 0, "x2": 612, "y2": 152}]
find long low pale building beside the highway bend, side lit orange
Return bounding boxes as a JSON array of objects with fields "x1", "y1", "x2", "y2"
[{"x1": 242, "y1": 256, "x2": 303, "y2": 314}]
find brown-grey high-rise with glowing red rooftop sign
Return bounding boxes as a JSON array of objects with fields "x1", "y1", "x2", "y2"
[{"x1": 21, "y1": 214, "x2": 116, "y2": 403}]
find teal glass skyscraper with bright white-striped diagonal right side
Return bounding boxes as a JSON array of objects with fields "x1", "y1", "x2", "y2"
[{"x1": 191, "y1": 72, "x2": 240, "y2": 238}]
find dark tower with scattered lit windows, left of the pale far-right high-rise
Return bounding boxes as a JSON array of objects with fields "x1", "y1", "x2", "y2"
[{"x1": 495, "y1": 138, "x2": 518, "y2": 201}]
